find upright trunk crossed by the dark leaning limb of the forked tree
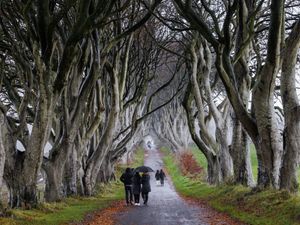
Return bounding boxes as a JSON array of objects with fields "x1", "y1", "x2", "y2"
[{"x1": 231, "y1": 0, "x2": 254, "y2": 186}]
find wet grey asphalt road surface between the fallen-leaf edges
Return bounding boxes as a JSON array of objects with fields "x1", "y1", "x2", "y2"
[{"x1": 116, "y1": 149, "x2": 207, "y2": 225}]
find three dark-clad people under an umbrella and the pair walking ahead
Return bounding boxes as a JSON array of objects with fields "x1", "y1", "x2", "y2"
[{"x1": 120, "y1": 168, "x2": 165, "y2": 206}]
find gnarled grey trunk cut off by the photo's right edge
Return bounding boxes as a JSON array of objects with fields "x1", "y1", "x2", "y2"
[{"x1": 280, "y1": 20, "x2": 300, "y2": 192}]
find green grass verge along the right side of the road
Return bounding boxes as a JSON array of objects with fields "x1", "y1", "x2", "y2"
[{"x1": 162, "y1": 149, "x2": 300, "y2": 225}]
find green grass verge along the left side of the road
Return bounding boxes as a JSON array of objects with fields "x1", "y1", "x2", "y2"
[{"x1": 0, "y1": 149, "x2": 144, "y2": 225}]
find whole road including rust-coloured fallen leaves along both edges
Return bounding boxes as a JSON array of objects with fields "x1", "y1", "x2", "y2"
[{"x1": 79, "y1": 150, "x2": 246, "y2": 225}]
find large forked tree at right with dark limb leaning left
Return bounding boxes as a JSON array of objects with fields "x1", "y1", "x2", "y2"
[{"x1": 173, "y1": 0, "x2": 297, "y2": 191}]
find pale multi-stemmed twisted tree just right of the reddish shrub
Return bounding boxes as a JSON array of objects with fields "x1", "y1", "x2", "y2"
[{"x1": 183, "y1": 35, "x2": 233, "y2": 184}]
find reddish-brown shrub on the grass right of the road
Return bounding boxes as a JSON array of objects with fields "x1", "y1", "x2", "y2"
[{"x1": 179, "y1": 151, "x2": 203, "y2": 177}]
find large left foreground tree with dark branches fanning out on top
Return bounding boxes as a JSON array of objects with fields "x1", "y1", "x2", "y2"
[{"x1": 1, "y1": 1, "x2": 163, "y2": 207}]
